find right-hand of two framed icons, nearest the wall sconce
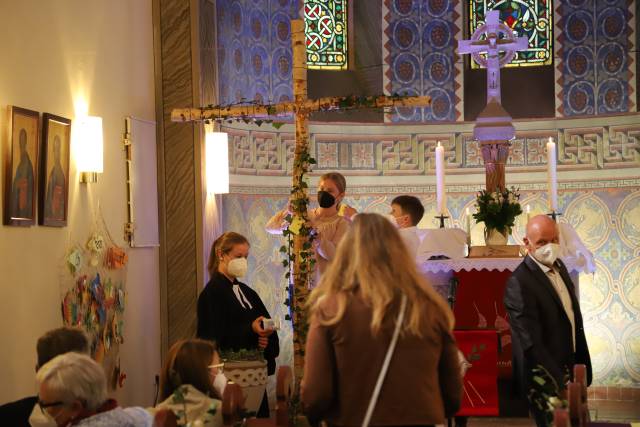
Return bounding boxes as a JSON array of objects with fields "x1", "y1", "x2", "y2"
[{"x1": 38, "y1": 113, "x2": 71, "y2": 227}]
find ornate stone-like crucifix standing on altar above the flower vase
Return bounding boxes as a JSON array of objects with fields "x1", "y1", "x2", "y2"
[{"x1": 458, "y1": 10, "x2": 529, "y2": 192}]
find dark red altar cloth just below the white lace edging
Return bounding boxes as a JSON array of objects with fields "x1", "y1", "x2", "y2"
[{"x1": 454, "y1": 270, "x2": 511, "y2": 379}]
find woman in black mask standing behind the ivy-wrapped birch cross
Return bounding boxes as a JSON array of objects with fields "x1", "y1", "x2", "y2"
[{"x1": 266, "y1": 172, "x2": 356, "y2": 283}]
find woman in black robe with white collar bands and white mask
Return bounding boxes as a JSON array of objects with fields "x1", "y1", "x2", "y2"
[{"x1": 197, "y1": 231, "x2": 280, "y2": 417}]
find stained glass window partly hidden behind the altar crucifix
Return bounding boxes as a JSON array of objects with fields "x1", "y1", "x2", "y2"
[{"x1": 469, "y1": 0, "x2": 553, "y2": 68}]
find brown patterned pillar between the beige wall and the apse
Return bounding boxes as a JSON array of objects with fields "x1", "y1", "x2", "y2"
[{"x1": 153, "y1": 0, "x2": 204, "y2": 356}]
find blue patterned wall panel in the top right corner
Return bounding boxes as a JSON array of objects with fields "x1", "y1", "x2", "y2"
[{"x1": 556, "y1": 0, "x2": 636, "y2": 116}]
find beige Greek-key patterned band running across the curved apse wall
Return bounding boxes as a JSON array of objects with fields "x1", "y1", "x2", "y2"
[{"x1": 221, "y1": 118, "x2": 640, "y2": 175}]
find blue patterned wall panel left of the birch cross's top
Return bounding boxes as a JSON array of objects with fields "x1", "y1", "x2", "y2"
[{"x1": 216, "y1": 0, "x2": 299, "y2": 104}]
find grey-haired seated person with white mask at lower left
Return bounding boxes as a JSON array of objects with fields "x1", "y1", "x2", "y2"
[{"x1": 36, "y1": 353, "x2": 153, "y2": 427}]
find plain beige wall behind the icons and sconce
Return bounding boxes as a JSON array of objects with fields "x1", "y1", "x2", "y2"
[{"x1": 0, "y1": 0, "x2": 160, "y2": 405}]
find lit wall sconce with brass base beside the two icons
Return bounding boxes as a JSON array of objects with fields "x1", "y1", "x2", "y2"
[{"x1": 72, "y1": 116, "x2": 103, "y2": 184}]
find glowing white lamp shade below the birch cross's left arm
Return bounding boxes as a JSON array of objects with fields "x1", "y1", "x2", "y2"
[{"x1": 205, "y1": 132, "x2": 229, "y2": 194}]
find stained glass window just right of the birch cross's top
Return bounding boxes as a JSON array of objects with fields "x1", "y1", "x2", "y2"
[{"x1": 304, "y1": 0, "x2": 348, "y2": 70}]
